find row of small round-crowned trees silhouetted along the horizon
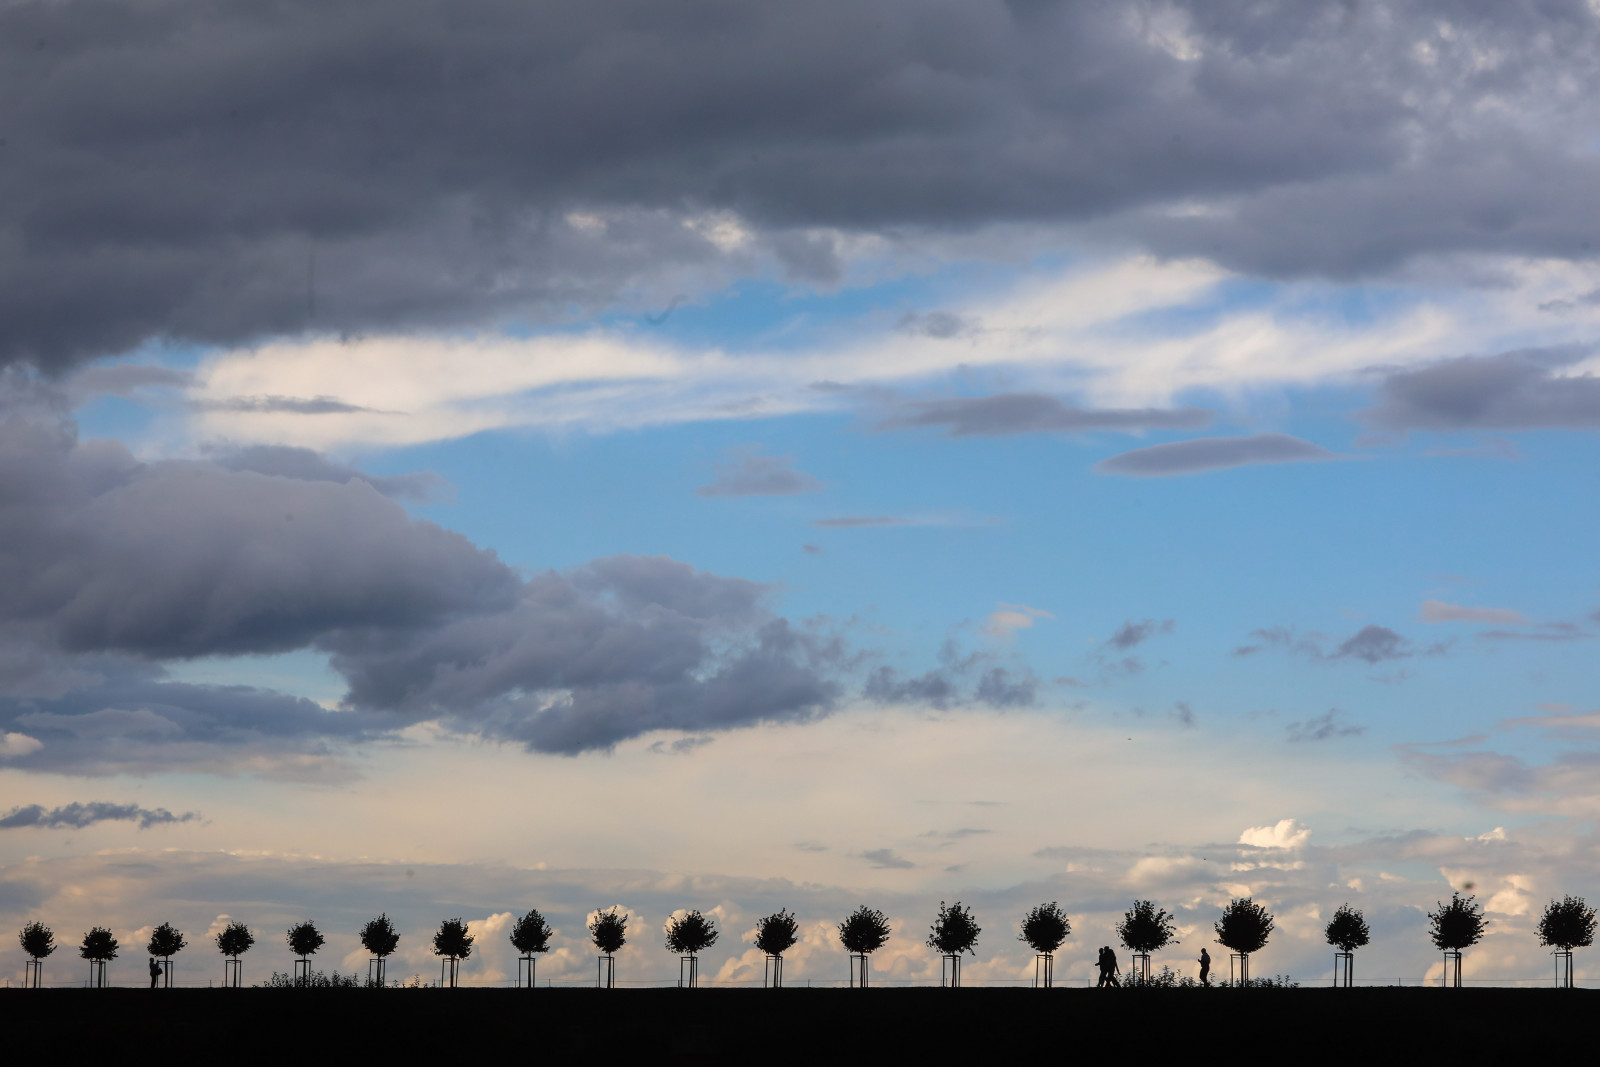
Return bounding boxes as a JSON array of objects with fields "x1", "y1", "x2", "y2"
[{"x1": 19, "y1": 893, "x2": 1597, "y2": 985}]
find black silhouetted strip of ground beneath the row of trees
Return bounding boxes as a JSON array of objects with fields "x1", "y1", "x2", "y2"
[{"x1": 0, "y1": 989, "x2": 1600, "y2": 1067}]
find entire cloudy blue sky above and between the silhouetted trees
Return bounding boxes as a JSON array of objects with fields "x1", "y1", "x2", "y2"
[{"x1": 0, "y1": 0, "x2": 1600, "y2": 984}]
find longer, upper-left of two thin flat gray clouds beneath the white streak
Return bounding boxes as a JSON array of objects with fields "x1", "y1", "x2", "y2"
[{"x1": 878, "y1": 394, "x2": 1211, "y2": 437}]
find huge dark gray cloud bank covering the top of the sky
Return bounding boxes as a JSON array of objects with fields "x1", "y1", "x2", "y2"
[{"x1": 0, "y1": 0, "x2": 1600, "y2": 366}]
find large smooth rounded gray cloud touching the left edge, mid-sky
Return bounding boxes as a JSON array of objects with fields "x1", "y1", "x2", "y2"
[{"x1": 0, "y1": 411, "x2": 518, "y2": 657}]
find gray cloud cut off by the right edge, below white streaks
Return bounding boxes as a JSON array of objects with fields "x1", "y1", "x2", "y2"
[{"x1": 1363, "y1": 347, "x2": 1600, "y2": 432}]
